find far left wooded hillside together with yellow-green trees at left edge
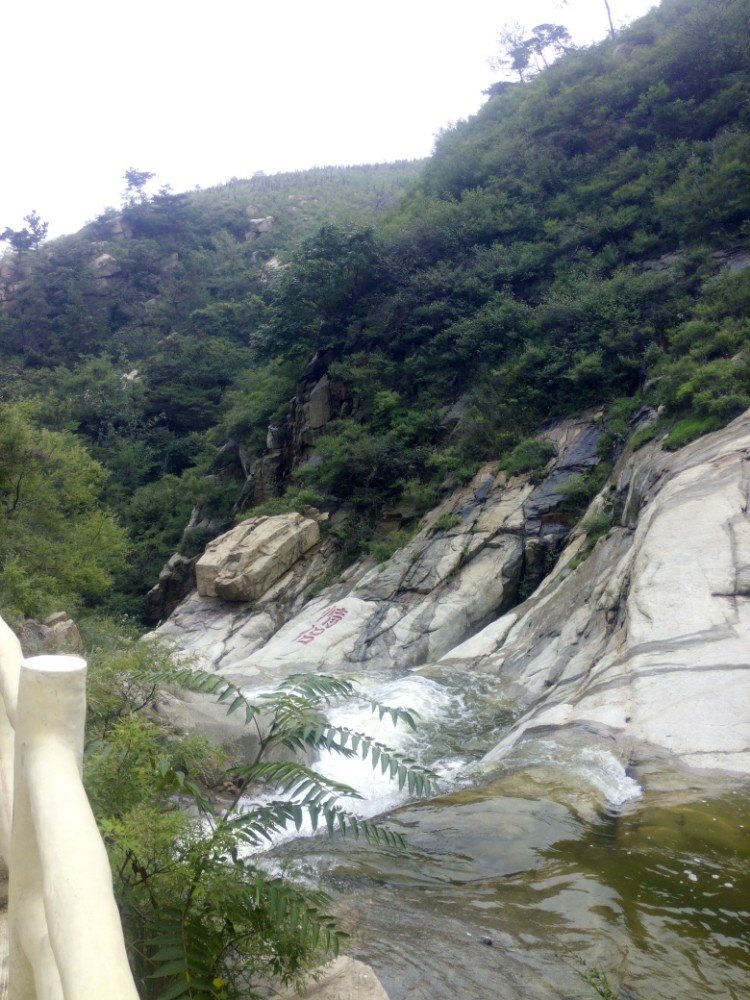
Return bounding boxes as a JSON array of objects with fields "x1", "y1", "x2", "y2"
[{"x1": 0, "y1": 163, "x2": 421, "y2": 618}]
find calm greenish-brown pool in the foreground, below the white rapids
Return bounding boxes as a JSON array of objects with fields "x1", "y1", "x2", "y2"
[{"x1": 276, "y1": 769, "x2": 750, "y2": 1000}]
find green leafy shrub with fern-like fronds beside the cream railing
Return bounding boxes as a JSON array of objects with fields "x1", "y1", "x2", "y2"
[{"x1": 86, "y1": 664, "x2": 436, "y2": 1000}]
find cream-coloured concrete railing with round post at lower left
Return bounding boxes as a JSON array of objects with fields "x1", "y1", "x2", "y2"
[{"x1": 0, "y1": 619, "x2": 138, "y2": 1000}]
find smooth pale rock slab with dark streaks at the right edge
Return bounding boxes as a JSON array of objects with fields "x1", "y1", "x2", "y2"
[{"x1": 434, "y1": 414, "x2": 750, "y2": 774}]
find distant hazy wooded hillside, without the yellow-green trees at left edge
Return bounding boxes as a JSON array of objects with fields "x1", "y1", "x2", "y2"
[{"x1": 0, "y1": 163, "x2": 419, "y2": 616}]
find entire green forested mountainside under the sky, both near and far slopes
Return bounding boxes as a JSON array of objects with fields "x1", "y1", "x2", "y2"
[{"x1": 0, "y1": 0, "x2": 750, "y2": 615}]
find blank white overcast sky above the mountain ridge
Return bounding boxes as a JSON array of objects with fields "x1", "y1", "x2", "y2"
[{"x1": 0, "y1": 0, "x2": 654, "y2": 235}]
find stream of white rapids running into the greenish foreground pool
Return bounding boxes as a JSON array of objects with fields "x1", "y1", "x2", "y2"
[{"x1": 247, "y1": 671, "x2": 750, "y2": 1000}]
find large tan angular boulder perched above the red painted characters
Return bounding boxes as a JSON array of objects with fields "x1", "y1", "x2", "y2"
[{"x1": 195, "y1": 514, "x2": 320, "y2": 601}]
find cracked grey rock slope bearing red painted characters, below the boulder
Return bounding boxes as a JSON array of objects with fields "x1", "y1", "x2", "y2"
[{"x1": 158, "y1": 418, "x2": 599, "y2": 683}]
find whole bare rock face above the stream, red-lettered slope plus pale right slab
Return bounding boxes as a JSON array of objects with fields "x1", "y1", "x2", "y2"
[{"x1": 159, "y1": 406, "x2": 750, "y2": 772}]
